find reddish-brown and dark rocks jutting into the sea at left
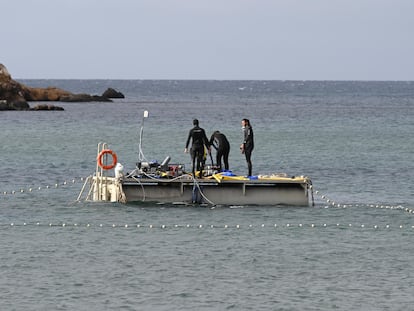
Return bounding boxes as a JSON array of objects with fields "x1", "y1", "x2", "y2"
[{"x1": 0, "y1": 64, "x2": 125, "y2": 111}]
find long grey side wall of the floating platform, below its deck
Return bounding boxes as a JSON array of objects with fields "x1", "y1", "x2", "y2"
[{"x1": 122, "y1": 179, "x2": 309, "y2": 206}]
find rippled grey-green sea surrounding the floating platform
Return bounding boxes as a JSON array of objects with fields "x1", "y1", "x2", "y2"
[{"x1": 0, "y1": 80, "x2": 414, "y2": 310}]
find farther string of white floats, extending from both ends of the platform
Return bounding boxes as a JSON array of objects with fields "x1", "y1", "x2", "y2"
[{"x1": 0, "y1": 177, "x2": 414, "y2": 214}]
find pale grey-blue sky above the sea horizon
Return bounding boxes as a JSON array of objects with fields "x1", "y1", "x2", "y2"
[{"x1": 0, "y1": 0, "x2": 414, "y2": 80}]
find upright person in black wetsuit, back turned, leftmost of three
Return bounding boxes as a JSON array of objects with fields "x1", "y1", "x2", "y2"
[{"x1": 184, "y1": 119, "x2": 211, "y2": 177}]
